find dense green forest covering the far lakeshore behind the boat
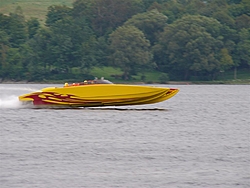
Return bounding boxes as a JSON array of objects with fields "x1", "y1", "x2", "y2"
[{"x1": 0, "y1": 0, "x2": 250, "y2": 81}]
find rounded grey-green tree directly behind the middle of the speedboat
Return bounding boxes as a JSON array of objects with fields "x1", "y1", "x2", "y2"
[{"x1": 110, "y1": 26, "x2": 152, "y2": 80}]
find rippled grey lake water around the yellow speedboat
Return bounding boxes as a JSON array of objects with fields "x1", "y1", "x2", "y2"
[{"x1": 0, "y1": 84, "x2": 250, "y2": 188}]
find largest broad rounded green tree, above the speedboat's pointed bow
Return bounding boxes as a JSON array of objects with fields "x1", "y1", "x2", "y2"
[{"x1": 156, "y1": 16, "x2": 222, "y2": 80}]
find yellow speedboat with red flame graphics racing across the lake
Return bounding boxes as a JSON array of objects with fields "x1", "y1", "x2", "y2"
[{"x1": 19, "y1": 79, "x2": 179, "y2": 107}]
